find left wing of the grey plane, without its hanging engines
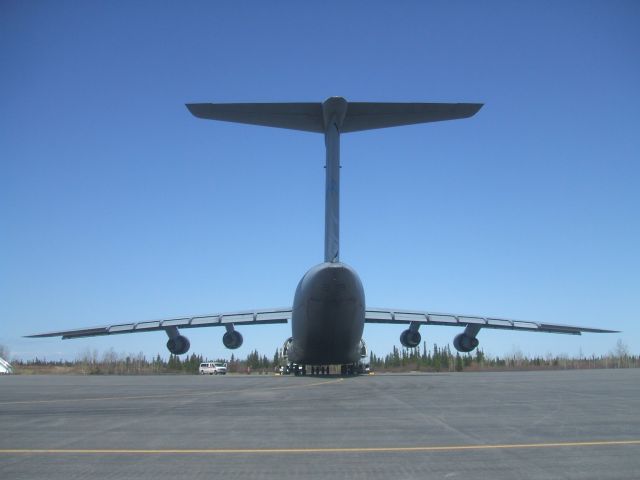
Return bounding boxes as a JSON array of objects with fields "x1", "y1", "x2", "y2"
[{"x1": 27, "y1": 308, "x2": 291, "y2": 340}]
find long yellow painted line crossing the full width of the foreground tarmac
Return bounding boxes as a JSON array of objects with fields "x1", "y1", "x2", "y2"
[{"x1": 0, "y1": 440, "x2": 640, "y2": 455}]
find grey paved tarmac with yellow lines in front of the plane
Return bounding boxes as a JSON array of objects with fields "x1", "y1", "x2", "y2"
[{"x1": 0, "y1": 369, "x2": 640, "y2": 480}]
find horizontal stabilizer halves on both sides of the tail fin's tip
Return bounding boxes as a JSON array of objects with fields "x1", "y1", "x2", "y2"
[{"x1": 187, "y1": 98, "x2": 482, "y2": 133}]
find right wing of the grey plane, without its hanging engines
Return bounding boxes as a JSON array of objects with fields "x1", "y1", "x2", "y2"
[{"x1": 365, "y1": 308, "x2": 618, "y2": 335}]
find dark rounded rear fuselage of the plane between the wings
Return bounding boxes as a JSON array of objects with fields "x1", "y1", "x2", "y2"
[{"x1": 289, "y1": 262, "x2": 365, "y2": 365}]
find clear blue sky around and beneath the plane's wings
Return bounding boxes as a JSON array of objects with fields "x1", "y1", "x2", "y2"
[{"x1": 0, "y1": 1, "x2": 640, "y2": 359}]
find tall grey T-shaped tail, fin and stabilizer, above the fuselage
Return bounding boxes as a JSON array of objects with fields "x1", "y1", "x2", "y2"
[{"x1": 187, "y1": 97, "x2": 482, "y2": 263}]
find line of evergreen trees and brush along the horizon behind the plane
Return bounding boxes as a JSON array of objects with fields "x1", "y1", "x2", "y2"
[{"x1": 5, "y1": 340, "x2": 640, "y2": 375}]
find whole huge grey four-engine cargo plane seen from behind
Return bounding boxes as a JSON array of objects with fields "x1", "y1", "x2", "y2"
[{"x1": 31, "y1": 97, "x2": 614, "y2": 374}]
